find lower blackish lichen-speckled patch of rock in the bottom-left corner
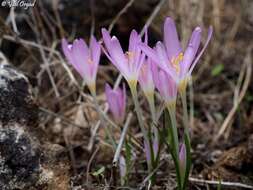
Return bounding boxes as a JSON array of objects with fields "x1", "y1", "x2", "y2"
[{"x1": 0, "y1": 125, "x2": 40, "y2": 190}]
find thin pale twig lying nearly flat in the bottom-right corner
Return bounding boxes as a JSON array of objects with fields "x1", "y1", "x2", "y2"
[{"x1": 189, "y1": 177, "x2": 253, "y2": 189}]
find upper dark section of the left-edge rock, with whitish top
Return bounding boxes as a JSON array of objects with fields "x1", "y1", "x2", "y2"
[{"x1": 0, "y1": 64, "x2": 38, "y2": 124}]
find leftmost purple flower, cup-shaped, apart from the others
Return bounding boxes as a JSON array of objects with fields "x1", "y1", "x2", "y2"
[{"x1": 62, "y1": 36, "x2": 101, "y2": 92}]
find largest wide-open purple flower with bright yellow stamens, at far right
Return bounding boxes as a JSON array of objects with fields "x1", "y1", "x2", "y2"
[{"x1": 141, "y1": 17, "x2": 213, "y2": 90}]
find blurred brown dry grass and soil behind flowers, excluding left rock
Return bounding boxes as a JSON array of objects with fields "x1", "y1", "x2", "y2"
[{"x1": 0, "y1": 0, "x2": 253, "y2": 189}]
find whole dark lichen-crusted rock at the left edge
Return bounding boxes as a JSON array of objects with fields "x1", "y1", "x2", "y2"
[{"x1": 0, "y1": 63, "x2": 69, "y2": 190}]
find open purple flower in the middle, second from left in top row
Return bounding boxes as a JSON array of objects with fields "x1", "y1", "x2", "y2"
[{"x1": 102, "y1": 28, "x2": 145, "y2": 85}]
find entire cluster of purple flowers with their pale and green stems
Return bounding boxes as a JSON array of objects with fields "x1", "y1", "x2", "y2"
[{"x1": 62, "y1": 17, "x2": 212, "y2": 189}]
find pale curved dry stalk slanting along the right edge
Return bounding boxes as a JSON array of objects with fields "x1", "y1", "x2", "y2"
[{"x1": 213, "y1": 46, "x2": 252, "y2": 142}]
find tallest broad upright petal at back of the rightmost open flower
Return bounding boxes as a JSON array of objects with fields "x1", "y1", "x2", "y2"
[{"x1": 163, "y1": 17, "x2": 182, "y2": 60}]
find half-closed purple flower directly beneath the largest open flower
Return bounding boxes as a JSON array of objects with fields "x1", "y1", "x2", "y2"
[{"x1": 152, "y1": 63, "x2": 177, "y2": 106}]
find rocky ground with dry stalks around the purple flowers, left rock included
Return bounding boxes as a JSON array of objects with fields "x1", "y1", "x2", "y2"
[{"x1": 0, "y1": 0, "x2": 253, "y2": 190}]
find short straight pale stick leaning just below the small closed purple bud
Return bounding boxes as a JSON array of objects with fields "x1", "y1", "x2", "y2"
[{"x1": 112, "y1": 113, "x2": 133, "y2": 165}]
